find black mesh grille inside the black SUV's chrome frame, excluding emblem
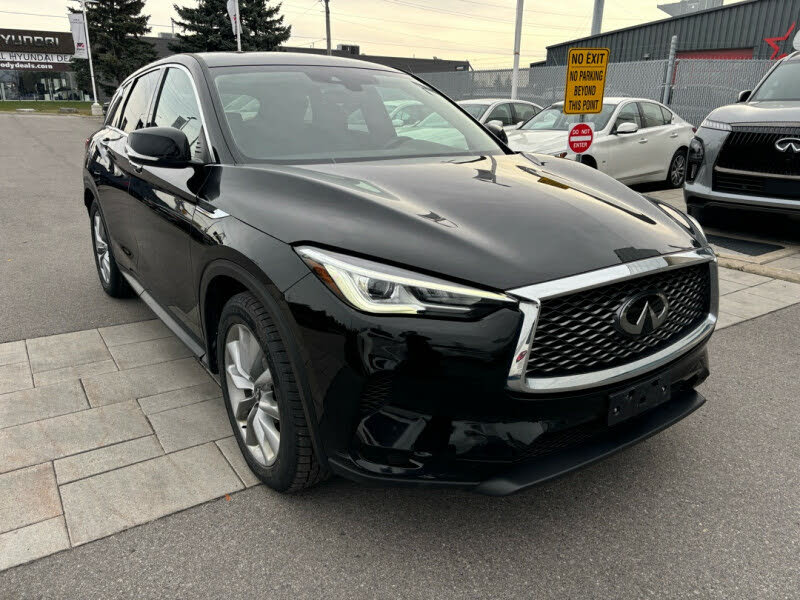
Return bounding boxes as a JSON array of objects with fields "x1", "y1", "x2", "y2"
[{"x1": 526, "y1": 263, "x2": 711, "y2": 377}]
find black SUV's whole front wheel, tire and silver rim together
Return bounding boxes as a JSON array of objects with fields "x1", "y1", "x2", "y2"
[{"x1": 217, "y1": 292, "x2": 322, "y2": 492}]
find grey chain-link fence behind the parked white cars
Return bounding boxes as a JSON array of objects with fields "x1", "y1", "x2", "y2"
[{"x1": 420, "y1": 59, "x2": 773, "y2": 125}]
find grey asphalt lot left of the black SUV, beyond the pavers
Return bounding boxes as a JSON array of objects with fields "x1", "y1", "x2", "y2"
[{"x1": 0, "y1": 113, "x2": 153, "y2": 343}]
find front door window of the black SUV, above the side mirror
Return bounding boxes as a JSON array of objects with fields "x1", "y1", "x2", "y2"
[{"x1": 153, "y1": 68, "x2": 203, "y2": 155}]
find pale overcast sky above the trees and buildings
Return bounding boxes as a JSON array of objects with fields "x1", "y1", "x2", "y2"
[{"x1": 0, "y1": 0, "x2": 736, "y2": 68}]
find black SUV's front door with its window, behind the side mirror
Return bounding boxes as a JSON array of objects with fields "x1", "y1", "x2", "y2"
[{"x1": 124, "y1": 65, "x2": 210, "y2": 339}]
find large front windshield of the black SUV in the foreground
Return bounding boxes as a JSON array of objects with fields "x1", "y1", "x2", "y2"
[{"x1": 212, "y1": 66, "x2": 503, "y2": 163}]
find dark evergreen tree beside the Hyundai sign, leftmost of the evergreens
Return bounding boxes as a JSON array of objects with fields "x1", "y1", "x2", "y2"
[{"x1": 70, "y1": 0, "x2": 156, "y2": 95}]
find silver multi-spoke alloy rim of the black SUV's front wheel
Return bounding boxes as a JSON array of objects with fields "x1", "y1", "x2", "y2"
[{"x1": 224, "y1": 324, "x2": 281, "y2": 466}]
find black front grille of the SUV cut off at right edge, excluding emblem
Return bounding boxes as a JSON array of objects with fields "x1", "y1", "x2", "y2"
[{"x1": 716, "y1": 125, "x2": 800, "y2": 175}]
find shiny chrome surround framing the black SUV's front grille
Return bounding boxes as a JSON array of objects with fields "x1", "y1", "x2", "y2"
[{"x1": 506, "y1": 247, "x2": 719, "y2": 393}]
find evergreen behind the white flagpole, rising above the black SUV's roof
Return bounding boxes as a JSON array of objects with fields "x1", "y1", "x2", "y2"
[{"x1": 169, "y1": 0, "x2": 292, "y2": 52}]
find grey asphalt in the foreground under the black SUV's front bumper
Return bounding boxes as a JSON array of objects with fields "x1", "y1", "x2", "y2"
[{"x1": 0, "y1": 307, "x2": 800, "y2": 600}]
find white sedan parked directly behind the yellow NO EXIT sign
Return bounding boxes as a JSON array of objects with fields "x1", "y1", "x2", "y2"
[{"x1": 507, "y1": 98, "x2": 695, "y2": 187}]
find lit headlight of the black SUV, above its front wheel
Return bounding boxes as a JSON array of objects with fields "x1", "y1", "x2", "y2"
[{"x1": 295, "y1": 246, "x2": 516, "y2": 316}]
